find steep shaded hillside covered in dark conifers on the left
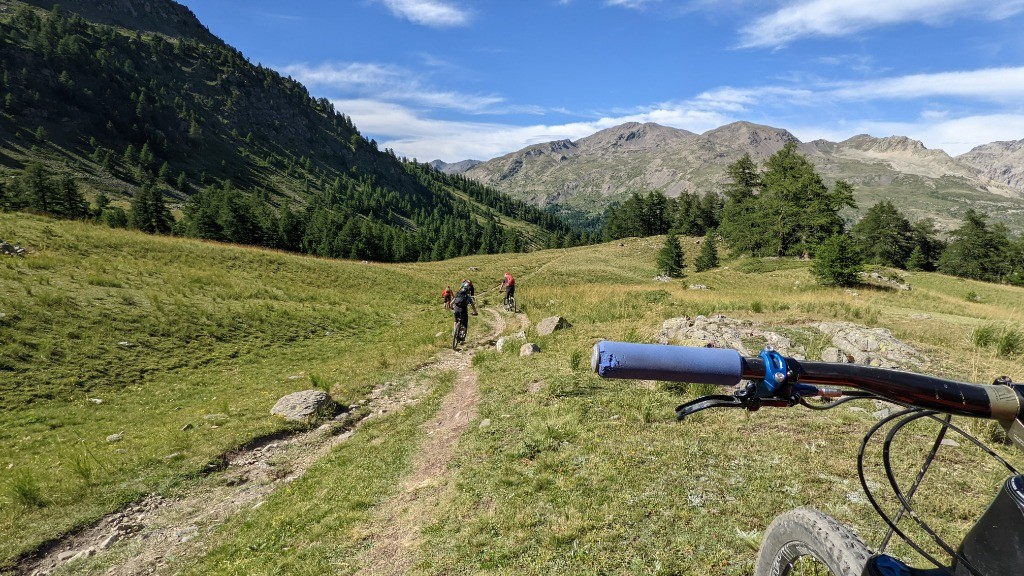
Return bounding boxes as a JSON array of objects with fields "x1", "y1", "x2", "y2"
[{"x1": 0, "y1": 0, "x2": 582, "y2": 261}]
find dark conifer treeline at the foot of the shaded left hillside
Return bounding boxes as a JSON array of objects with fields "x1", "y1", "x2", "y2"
[{"x1": 0, "y1": 163, "x2": 562, "y2": 261}]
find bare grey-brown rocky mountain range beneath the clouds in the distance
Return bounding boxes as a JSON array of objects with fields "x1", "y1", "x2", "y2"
[{"x1": 458, "y1": 122, "x2": 1024, "y2": 232}]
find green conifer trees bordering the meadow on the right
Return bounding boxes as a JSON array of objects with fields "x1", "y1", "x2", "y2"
[{"x1": 622, "y1": 143, "x2": 1024, "y2": 285}]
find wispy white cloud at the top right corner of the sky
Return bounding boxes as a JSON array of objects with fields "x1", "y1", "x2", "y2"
[{"x1": 740, "y1": 0, "x2": 1024, "y2": 48}]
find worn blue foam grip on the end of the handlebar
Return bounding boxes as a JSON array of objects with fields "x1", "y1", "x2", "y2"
[{"x1": 590, "y1": 340, "x2": 742, "y2": 386}]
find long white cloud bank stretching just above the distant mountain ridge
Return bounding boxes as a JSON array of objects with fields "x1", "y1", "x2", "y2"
[{"x1": 315, "y1": 65, "x2": 1024, "y2": 162}]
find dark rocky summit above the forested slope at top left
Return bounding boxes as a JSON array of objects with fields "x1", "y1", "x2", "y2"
[{"x1": 24, "y1": 0, "x2": 221, "y2": 43}]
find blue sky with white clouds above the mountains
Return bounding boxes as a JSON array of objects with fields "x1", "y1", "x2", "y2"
[{"x1": 178, "y1": 0, "x2": 1024, "y2": 162}]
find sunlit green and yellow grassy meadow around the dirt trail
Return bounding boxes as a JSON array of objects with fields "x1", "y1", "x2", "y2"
[{"x1": 0, "y1": 215, "x2": 1024, "y2": 574}]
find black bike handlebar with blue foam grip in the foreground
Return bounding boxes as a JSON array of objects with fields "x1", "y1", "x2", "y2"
[{"x1": 591, "y1": 340, "x2": 1024, "y2": 422}]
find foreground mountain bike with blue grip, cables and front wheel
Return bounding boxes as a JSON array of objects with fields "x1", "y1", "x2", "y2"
[{"x1": 591, "y1": 340, "x2": 1024, "y2": 576}]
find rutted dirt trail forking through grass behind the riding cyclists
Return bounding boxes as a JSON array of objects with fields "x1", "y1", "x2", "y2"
[{"x1": 14, "y1": 308, "x2": 505, "y2": 576}]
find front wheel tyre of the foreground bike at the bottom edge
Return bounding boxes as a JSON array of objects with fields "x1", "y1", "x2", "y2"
[{"x1": 754, "y1": 508, "x2": 870, "y2": 576}]
